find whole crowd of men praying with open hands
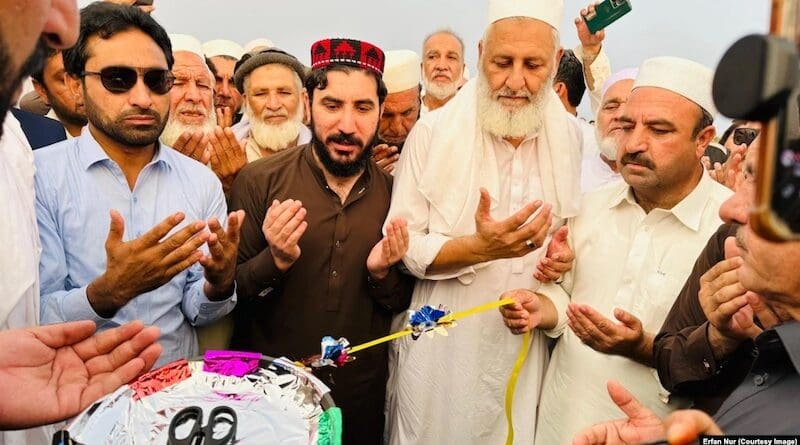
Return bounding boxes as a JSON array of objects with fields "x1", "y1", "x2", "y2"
[{"x1": 0, "y1": 0, "x2": 800, "y2": 445}]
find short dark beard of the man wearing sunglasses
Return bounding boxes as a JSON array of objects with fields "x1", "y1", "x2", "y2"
[{"x1": 83, "y1": 86, "x2": 168, "y2": 147}]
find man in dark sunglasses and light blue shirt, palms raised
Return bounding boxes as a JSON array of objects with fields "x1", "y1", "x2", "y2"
[{"x1": 35, "y1": 3, "x2": 242, "y2": 365}]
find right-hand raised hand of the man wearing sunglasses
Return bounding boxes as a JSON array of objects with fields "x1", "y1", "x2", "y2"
[{"x1": 200, "y1": 210, "x2": 244, "y2": 300}]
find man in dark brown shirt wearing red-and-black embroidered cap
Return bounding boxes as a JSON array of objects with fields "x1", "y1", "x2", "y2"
[{"x1": 231, "y1": 39, "x2": 412, "y2": 444}]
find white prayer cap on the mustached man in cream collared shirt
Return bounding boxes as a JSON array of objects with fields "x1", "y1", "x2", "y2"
[{"x1": 633, "y1": 57, "x2": 716, "y2": 116}]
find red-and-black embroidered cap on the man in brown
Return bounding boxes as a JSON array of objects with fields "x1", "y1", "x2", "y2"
[{"x1": 311, "y1": 39, "x2": 386, "y2": 76}]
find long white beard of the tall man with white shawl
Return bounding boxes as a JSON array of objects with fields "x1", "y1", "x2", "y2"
[{"x1": 478, "y1": 72, "x2": 552, "y2": 138}]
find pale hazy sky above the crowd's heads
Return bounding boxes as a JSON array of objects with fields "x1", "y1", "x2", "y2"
[{"x1": 78, "y1": 0, "x2": 771, "y2": 118}]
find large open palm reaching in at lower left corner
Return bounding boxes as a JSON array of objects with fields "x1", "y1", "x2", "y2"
[{"x1": 0, "y1": 321, "x2": 161, "y2": 429}]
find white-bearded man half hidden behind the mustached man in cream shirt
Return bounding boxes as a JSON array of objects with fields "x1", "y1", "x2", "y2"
[{"x1": 581, "y1": 68, "x2": 639, "y2": 193}]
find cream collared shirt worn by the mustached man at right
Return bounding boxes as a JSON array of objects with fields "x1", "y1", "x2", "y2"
[{"x1": 536, "y1": 172, "x2": 731, "y2": 445}]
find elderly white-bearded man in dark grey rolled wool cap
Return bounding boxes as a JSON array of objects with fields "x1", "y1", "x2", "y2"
[{"x1": 233, "y1": 48, "x2": 311, "y2": 162}]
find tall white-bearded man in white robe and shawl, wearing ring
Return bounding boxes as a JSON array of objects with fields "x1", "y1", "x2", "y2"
[{"x1": 387, "y1": 0, "x2": 581, "y2": 444}]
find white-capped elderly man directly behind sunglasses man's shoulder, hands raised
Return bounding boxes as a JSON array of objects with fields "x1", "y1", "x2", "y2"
[{"x1": 160, "y1": 34, "x2": 246, "y2": 193}]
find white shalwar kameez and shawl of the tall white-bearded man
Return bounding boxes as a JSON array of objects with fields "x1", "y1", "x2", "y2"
[{"x1": 387, "y1": 81, "x2": 580, "y2": 445}]
